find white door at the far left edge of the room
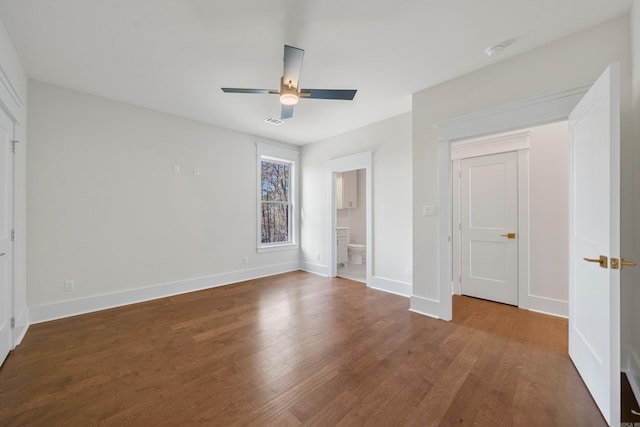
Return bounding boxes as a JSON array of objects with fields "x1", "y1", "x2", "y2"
[{"x1": 0, "y1": 110, "x2": 13, "y2": 364}]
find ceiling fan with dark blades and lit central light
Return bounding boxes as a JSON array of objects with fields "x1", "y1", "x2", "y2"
[{"x1": 222, "y1": 45, "x2": 357, "y2": 120}]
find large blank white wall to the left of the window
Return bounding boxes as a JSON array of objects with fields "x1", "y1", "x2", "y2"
[{"x1": 27, "y1": 80, "x2": 299, "y2": 321}]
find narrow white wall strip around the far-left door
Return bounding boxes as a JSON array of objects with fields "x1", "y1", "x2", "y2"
[{"x1": 0, "y1": 18, "x2": 28, "y2": 340}]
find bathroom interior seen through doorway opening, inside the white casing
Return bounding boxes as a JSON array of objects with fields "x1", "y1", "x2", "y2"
[{"x1": 335, "y1": 169, "x2": 367, "y2": 283}]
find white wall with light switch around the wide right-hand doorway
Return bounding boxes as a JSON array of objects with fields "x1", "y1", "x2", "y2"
[{"x1": 412, "y1": 16, "x2": 633, "y2": 315}]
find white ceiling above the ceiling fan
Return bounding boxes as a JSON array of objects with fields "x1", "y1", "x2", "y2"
[{"x1": 0, "y1": 0, "x2": 632, "y2": 144}]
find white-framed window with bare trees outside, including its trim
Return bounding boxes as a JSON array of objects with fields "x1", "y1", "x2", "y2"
[{"x1": 257, "y1": 144, "x2": 298, "y2": 251}]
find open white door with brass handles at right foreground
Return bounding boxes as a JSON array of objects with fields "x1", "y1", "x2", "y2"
[{"x1": 569, "y1": 65, "x2": 620, "y2": 425}]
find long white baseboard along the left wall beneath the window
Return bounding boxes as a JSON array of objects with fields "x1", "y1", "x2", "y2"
[{"x1": 29, "y1": 262, "x2": 300, "y2": 324}]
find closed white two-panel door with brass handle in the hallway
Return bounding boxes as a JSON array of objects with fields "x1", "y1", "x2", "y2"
[{"x1": 460, "y1": 152, "x2": 518, "y2": 305}]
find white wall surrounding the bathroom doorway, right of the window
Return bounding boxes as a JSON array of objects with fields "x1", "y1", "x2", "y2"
[{"x1": 301, "y1": 113, "x2": 412, "y2": 296}]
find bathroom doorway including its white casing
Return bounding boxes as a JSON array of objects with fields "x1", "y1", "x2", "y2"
[{"x1": 328, "y1": 152, "x2": 373, "y2": 286}]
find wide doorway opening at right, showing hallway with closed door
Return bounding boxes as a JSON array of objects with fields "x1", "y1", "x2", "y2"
[{"x1": 451, "y1": 121, "x2": 569, "y2": 316}]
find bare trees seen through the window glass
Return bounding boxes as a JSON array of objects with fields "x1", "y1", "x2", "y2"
[{"x1": 261, "y1": 160, "x2": 291, "y2": 244}]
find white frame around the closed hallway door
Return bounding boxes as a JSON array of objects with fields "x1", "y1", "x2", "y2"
[{"x1": 450, "y1": 129, "x2": 531, "y2": 308}]
